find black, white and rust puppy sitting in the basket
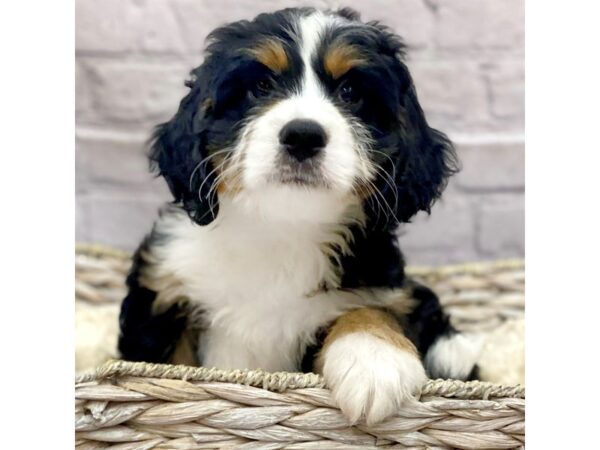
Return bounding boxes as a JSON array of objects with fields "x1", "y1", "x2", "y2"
[{"x1": 119, "y1": 8, "x2": 475, "y2": 423}]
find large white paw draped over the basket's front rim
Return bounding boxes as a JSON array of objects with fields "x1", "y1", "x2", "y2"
[{"x1": 323, "y1": 332, "x2": 427, "y2": 425}]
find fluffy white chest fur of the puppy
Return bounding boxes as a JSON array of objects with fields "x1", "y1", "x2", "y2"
[{"x1": 152, "y1": 205, "x2": 372, "y2": 371}]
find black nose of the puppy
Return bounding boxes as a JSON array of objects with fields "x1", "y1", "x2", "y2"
[{"x1": 279, "y1": 119, "x2": 327, "y2": 161}]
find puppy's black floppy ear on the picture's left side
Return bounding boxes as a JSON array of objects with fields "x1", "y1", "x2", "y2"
[{"x1": 149, "y1": 68, "x2": 219, "y2": 225}]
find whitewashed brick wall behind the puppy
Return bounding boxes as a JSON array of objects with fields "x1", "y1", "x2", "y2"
[{"x1": 76, "y1": 0, "x2": 524, "y2": 264}]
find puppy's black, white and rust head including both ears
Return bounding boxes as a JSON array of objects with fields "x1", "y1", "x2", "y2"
[{"x1": 151, "y1": 9, "x2": 454, "y2": 227}]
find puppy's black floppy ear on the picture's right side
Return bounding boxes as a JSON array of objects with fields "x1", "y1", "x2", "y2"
[{"x1": 378, "y1": 67, "x2": 459, "y2": 228}]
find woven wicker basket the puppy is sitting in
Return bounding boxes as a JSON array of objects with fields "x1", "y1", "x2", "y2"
[{"x1": 75, "y1": 246, "x2": 525, "y2": 450}]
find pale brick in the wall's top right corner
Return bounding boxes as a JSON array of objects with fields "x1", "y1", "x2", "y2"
[{"x1": 436, "y1": 0, "x2": 525, "y2": 50}]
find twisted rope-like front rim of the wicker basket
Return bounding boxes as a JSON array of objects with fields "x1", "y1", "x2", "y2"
[{"x1": 75, "y1": 360, "x2": 525, "y2": 400}]
